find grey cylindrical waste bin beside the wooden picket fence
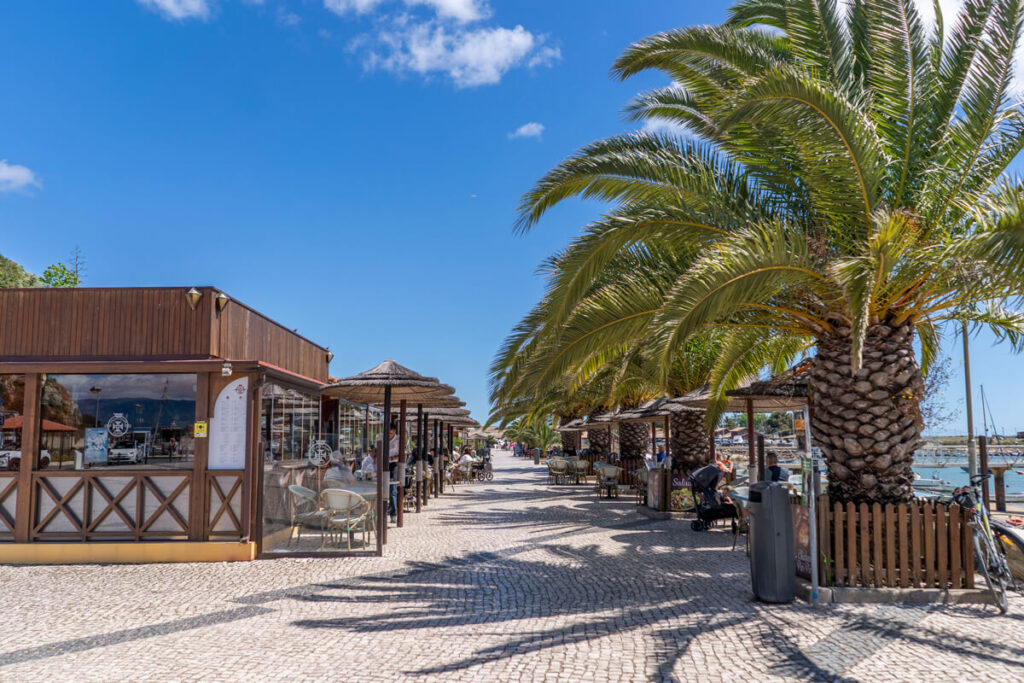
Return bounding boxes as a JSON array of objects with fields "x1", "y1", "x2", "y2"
[{"x1": 750, "y1": 481, "x2": 797, "y2": 602}]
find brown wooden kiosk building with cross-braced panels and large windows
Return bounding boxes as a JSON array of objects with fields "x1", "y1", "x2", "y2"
[{"x1": 0, "y1": 287, "x2": 332, "y2": 563}]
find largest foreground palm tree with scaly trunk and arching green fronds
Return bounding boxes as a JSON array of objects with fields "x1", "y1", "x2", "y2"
[{"x1": 520, "y1": 0, "x2": 1024, "y2": 502}]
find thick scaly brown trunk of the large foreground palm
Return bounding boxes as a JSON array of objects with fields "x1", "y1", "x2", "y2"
[{"x1": 810, "y1": 322, "x2": 924, "y2": 503}]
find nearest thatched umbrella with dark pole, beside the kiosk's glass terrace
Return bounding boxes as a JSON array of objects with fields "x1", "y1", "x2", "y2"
[{"x1": 323, "y1": 359, "x2": 455, "y2": 554}]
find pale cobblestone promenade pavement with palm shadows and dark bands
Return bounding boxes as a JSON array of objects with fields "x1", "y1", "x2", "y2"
[{"x1": 0, "y1": 454, "x2": 1024, "y2": 683}]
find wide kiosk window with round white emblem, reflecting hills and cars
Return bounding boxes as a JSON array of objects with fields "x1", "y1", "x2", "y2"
[{"x1": 39, "y1": 375, "x2": 196, "y2": 469}]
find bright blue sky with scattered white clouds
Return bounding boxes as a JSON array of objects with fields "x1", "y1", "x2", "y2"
[{"x1": 0, "y1": 0, "x2": 1024, "y2": 431}]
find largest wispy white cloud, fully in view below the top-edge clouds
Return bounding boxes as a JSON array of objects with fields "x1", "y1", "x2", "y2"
[{"x1": 364, "y1": 17, "x2": 561, "y2": 88}]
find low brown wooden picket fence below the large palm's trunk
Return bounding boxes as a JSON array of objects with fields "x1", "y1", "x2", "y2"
[{"x1": 817, "y1": 496, "x2": 974, "y2": 589}]
